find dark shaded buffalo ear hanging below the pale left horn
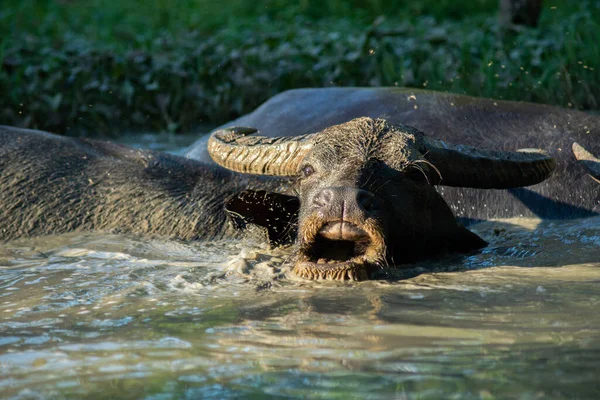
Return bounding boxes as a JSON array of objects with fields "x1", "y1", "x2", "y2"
[{"x1": 225, "y1": 190, "x2": 300, "y2": 246}]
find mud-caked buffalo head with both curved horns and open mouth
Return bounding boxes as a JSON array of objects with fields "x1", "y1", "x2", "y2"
[{"x1": 208, "y1": 118, "x2": 554, "y2": 280}]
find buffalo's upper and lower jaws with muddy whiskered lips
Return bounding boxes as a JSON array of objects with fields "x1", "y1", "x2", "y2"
[{"x1": 293, "y1": 216, "x2": 387, "y2": 281}]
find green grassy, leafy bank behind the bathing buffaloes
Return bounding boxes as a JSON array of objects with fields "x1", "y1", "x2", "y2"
[{"x1": 0, "y1": 0, "x2": 600, "y2": 134}]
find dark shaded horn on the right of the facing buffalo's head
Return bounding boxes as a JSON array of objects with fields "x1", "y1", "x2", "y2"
[{"x1": 423, "y1": 137, "x2": 556, "y2": 189}]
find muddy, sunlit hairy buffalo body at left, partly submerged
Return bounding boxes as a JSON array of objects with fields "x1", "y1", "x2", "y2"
[{"x1": 0, "y1": 127, "x2": 279, "y2": 240}]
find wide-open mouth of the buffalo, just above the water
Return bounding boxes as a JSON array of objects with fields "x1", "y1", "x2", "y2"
[{"x1": 294, "y1": 221, "x2": 384, "y2": 280}]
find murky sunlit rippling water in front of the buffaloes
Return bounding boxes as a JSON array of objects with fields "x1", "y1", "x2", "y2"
[{"x1": 0, "y1": 134, "x2": 600, "y2": 399}]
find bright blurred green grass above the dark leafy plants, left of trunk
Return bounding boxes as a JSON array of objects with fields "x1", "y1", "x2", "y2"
[{"x1": 0, "y1": 0, "x2": 497, "y2": 43}]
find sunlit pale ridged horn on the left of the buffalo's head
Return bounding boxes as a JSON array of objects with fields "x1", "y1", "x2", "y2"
[{"x1": 208, "y1": 127, "x2": 314, "y2": 176}]
